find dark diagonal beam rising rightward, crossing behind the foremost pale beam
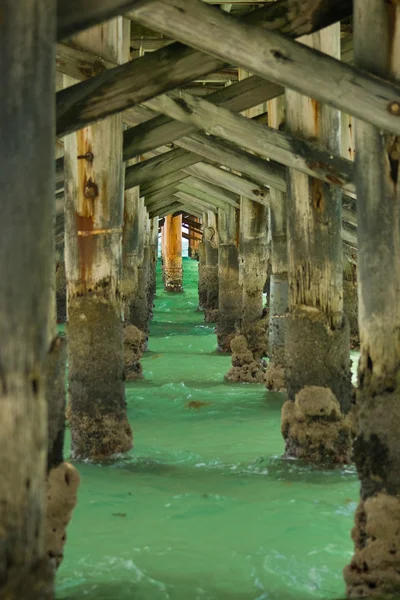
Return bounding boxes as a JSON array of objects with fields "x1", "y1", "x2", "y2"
[{"x1": 56, "y1": 0, "x2": 351, "y2": 136}]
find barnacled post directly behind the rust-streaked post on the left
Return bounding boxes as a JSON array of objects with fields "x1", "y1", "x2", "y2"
[{"x1": 121, "y1": 157, "x2": 146, "y2": 381}]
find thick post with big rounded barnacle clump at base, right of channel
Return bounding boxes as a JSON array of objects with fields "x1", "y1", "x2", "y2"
[{"x1": 282, "y1": 25, "x2": 353, "y2": 464}]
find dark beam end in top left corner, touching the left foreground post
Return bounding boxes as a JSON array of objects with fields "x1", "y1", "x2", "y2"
[{"x1": 57, "y1": 0, "x2": 138, "y2": 40}]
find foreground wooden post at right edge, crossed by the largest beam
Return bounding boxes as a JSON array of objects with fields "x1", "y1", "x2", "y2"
[{"x1": 344, "y1": 0, "x2": 400, "y2": 598}]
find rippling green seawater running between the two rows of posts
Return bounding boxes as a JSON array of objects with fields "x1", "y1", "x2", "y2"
[{"x1": 57, "y1": 259, "x2": 359, "y2": 600}]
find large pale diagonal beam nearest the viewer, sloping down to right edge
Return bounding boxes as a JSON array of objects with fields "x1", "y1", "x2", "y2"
[{"x1": 130, "y1": 0, "x2": 400, "y2": 134}]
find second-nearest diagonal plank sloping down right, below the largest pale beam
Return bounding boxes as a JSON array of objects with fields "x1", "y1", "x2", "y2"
[{"x1": 145, "y1": 91, "x2": 354, "y2": 192}]
